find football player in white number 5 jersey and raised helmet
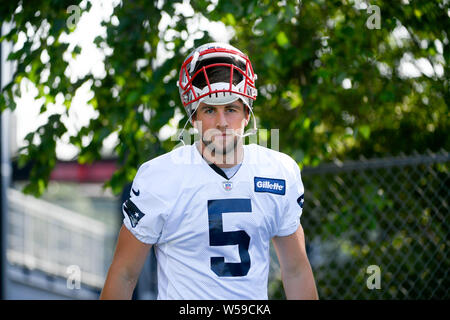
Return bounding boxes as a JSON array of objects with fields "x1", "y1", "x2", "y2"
[{"x1": 101, "y1": 43, "x2": 318, "y2": 300}]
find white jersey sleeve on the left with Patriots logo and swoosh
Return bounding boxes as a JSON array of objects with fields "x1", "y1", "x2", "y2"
[{"x1": 122, "y1": 165, "x2": 168, "y2": 244}]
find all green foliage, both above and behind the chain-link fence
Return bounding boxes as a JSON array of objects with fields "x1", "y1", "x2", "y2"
[{"x1": 0, "y1": 0, "x2": 450, "y2": 299}]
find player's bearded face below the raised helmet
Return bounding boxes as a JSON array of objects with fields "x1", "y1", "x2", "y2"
[{"x1": 194, "y1": 100, "x2": 249, "y2": 156}]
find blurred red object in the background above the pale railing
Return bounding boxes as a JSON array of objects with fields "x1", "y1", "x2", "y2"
[{"x1": 50, "y1": 161, "x2": 117, "y2": 182}]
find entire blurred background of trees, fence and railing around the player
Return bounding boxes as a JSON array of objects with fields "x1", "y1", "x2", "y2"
[{"x1": 0, "y1": 0, "x2": 450, "y2": 299}]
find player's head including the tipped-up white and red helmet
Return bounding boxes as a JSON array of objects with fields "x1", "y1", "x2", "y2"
[{"x1": 178, "y1": 43, "x2": 257, "y2": 159}]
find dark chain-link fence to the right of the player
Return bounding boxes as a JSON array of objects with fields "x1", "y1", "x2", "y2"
[{"x1": 269, "y1": 151, "x2": 450, "y2": 299}]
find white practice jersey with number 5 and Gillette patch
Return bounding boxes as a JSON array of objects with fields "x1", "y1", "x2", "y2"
[{"x1": 123, "y1": 144, "x2": 303, "y2": 300}]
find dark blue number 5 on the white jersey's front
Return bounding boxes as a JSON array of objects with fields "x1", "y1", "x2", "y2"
[{"x1": 208, "y1": 199, "x2": 252, "y2": 277}]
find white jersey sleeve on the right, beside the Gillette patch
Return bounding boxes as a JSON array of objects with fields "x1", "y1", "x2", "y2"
[{"x1": 276, "y1": 160, "x2": 304, "y2": 237}]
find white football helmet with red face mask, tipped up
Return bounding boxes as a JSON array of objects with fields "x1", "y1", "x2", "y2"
[{"x1": 177, "y1": 42, "x2": 257, "y2": 121}]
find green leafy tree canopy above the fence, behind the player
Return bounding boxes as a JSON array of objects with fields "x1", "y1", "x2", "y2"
[{"x1": 0, "y1": 0, "x2": 450, "y2": 196}]
